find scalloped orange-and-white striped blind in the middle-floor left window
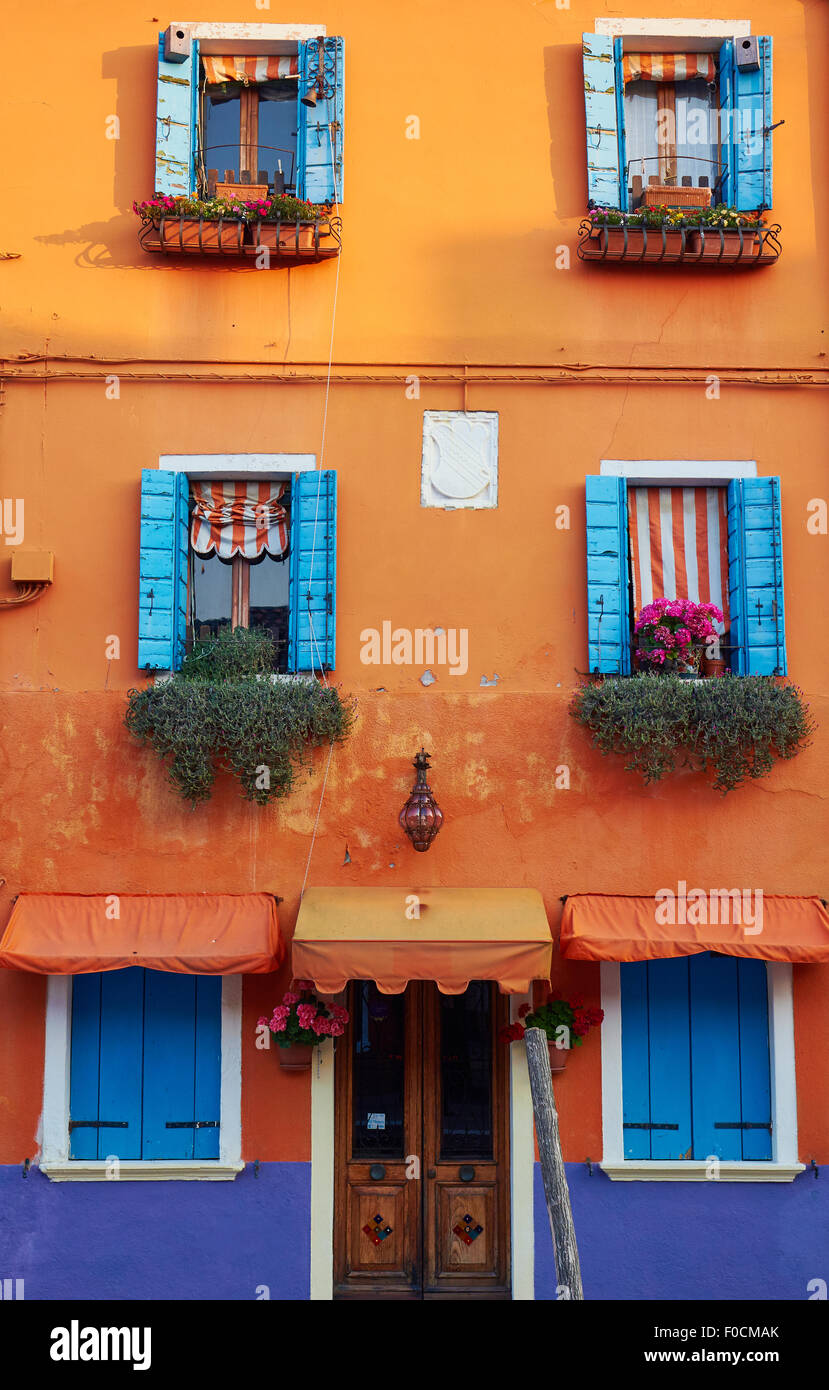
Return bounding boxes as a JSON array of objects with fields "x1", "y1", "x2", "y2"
[{"x1": 191, "y1": 482, "x2": 288, "y2": 560}]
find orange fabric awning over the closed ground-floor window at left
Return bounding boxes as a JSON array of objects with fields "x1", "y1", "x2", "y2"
[{"x1": 0, "y1": 892, "x2": 285, "y2": 974}]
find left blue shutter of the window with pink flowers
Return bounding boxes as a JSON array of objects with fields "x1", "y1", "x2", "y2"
[{"x1": 584, "y1": 474, "x2": 630, "y2": 676}]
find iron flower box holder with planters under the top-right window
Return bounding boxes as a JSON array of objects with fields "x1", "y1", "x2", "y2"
[{"x1": 579, "y1": 218, "x2": 782, "y2": 267}]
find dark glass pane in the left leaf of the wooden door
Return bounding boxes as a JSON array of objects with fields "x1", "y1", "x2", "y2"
[{"x1": 351, "y1": 980, "x2": 406, "y2": 1158}]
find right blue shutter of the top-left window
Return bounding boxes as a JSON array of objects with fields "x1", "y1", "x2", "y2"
[{"x1": 296, "y1": 38, "x2": 345, "y2": 203}]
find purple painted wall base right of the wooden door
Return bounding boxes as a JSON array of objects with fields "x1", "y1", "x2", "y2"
[{"x1": 536, "y1": 1163, "x2": 829, "y2": 1300}]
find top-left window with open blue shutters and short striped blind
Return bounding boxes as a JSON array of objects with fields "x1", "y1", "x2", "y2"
[{"x1": 156, "y1": 24, "x2": 344, "y2": 203}]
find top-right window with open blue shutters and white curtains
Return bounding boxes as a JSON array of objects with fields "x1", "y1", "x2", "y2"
[{"x1": 583, "y1": 33, "x2": 772, "y2": 211}]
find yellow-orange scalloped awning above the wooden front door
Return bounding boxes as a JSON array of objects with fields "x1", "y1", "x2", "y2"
[{"x1": 292, "y1": 888, "x2": 552, "y2": 994}]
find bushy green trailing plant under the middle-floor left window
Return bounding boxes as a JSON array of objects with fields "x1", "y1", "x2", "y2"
[{"x1": 124, "y1": 628, "x2": 353, "y2": 806}]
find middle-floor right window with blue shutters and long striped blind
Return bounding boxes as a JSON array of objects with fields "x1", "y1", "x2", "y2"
[{"x1": 586, "y1": 472, "x2": 786, "y2": 676}]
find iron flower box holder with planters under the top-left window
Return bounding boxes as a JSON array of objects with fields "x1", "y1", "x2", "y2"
[{"x1": 139, "y1": 217, "x2": 341, "y2": 265}]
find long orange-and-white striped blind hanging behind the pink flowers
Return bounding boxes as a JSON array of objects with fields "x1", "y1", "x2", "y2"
[{"x1": 627, "y1": 488, "x2": 729, "y2": 628}]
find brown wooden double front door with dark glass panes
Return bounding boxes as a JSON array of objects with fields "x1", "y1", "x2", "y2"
[{"x1": 334, "y1": 981, "x2": 509, "y2": 1298}]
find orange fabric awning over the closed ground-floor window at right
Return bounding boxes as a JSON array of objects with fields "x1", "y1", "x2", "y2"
[{"x1": 561, "y1": 885, "x2": 829, "y2": 965}]
